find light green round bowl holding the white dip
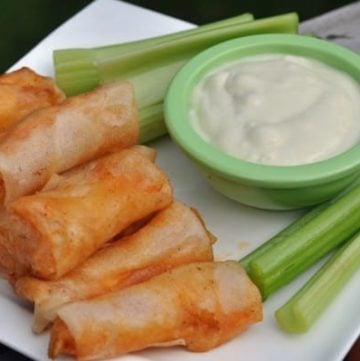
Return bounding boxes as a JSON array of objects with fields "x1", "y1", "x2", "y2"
[{"x1": 165, "y1": 34, "x2": 360, "y2": 210}]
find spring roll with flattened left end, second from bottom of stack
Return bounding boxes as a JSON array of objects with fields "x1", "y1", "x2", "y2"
[{"x1": 15, "y1": 201, "x2": 214, "y2": 332}]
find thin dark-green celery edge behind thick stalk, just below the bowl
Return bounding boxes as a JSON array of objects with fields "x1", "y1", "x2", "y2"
[{"x1": 239, "y1": 202, "x2": 329, "y2": 272}]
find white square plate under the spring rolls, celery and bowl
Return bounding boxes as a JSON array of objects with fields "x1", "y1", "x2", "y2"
[{"x1": 0, "y1": 0, "x2": 360, "y2": 361}]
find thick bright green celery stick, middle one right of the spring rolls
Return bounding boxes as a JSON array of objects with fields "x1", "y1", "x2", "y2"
[{"x1": 248, "y1": 185, "x2": 360, "y2": 299}]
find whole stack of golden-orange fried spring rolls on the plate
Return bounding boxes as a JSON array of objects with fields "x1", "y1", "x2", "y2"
[{"x1": 0, "y1": 68, "x2": 262, "y2": 360}]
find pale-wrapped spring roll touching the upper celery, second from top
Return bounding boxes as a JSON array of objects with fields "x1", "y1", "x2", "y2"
[{"x1": 0, "y1": 82, "x2": 139, "y2": 204}]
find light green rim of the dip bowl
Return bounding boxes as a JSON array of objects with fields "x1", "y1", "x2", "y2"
[{"x1": 164, "y1": 34, "x2": 360, "y2": 188}]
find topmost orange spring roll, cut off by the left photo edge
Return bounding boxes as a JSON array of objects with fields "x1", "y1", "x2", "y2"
[{"x1": 0, "y1": 68, "x2": 65, "y2": 134}]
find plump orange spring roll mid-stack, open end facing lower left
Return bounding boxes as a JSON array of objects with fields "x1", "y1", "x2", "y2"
[{"x1": 9, "y1": 148, "x2": 172, "y2": 279}]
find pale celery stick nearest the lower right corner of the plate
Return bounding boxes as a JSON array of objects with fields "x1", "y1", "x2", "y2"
[{"x1": 275, "y1": 232, "x2": 360, "y2": 333}]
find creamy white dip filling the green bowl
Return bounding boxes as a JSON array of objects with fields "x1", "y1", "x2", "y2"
[{"x1": 190, "y1": 54, "x2": 360, "y2": 165}]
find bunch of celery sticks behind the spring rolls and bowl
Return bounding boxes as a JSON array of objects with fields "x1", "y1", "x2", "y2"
[{"x1": 54, "y1": 13, "x2": 298, "y2": 141}]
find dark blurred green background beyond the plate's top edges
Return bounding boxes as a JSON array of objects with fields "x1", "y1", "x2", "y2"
[{"x1": 0, "y1": 0, "x2": 352, "y2": 72}]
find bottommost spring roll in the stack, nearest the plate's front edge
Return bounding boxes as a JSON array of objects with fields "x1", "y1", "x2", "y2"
[{"x1": 49, "y1": 261, "x2": 262, "y2": 360}]
